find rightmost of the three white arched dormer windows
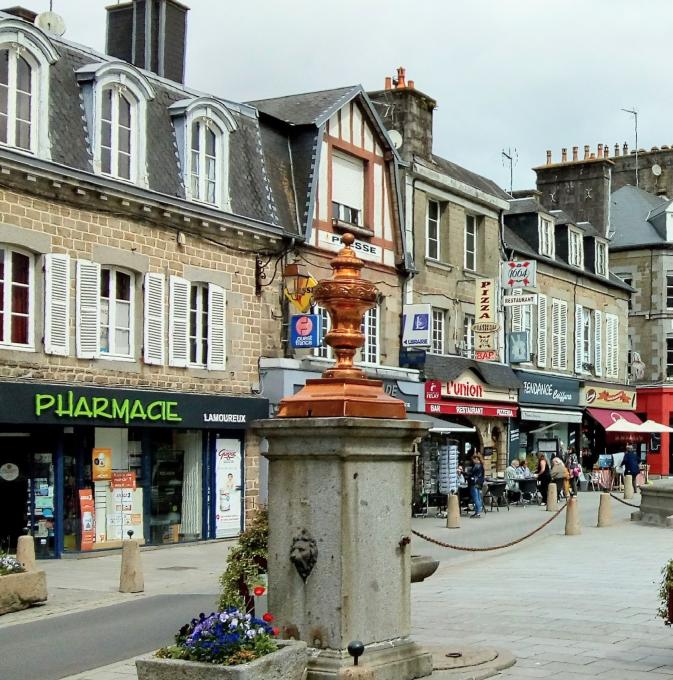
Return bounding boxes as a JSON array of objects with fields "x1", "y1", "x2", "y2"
[{"x1": 170, "y1": 97, "x2": 236, "y2": 210}]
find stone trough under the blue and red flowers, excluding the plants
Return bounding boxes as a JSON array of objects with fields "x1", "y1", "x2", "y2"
[{"x1": 136, "y1": 640, "x2": 307, "y2": 680}]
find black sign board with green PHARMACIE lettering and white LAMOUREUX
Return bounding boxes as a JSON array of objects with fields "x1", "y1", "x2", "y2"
[{"x1": 0, "y1": 382, "x2": 269, "y2": 430}]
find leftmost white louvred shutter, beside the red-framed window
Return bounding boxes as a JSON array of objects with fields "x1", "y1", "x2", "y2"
[{"x1": 44, "y1": 254, "x2": 70, "y2": 357}]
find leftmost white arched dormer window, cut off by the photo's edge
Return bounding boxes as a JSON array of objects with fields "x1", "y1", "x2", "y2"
[{"x1": 0, "y1": 19, "x2": 58, "y2": 158}]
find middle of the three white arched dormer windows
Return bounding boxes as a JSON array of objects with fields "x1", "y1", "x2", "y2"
[{"x1": 77, "y1": 62, "x2": 154, "y2": 186}]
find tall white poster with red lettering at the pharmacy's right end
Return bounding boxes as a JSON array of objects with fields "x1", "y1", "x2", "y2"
[{"x1": 215, "y1": 439, "x2": 241, "y2": 538}]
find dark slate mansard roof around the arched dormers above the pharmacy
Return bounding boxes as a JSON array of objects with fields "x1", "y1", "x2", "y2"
[{"x1": 0, "y1": 11, "x2": 280, "y2": 228}]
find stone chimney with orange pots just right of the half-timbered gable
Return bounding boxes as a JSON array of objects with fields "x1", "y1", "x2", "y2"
[{"x1": 367, "y1": 66, "x2": 437, "y2": 160}]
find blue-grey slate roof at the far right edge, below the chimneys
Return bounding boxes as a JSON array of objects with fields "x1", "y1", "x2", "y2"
[{"x1": 610, "y1": 186, "x2": 671, "y2": 249}]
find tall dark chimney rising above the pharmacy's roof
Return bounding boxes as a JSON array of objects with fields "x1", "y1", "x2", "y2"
[{"x1": 105, "y1": 0, "x2": 189, "y2": 83}]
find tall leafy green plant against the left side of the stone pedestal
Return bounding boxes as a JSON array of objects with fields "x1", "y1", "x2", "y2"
[{"x1": 220, "y1": 508, "x2": 269, "y2": 613}]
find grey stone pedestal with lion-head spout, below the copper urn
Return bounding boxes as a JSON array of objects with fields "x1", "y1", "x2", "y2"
[{"x1": 254, "y1": 417, "x2": 432, "y2": 680}]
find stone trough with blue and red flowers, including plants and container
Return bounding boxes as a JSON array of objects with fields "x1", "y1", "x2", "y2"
[{"x1": 136, "y1": 608, "x2": 307, "y2": 680}]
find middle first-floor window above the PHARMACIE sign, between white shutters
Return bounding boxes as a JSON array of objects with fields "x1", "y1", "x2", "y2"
[{"x1": 100, "y1": 267, "x2": 133, "y2": 357}]
